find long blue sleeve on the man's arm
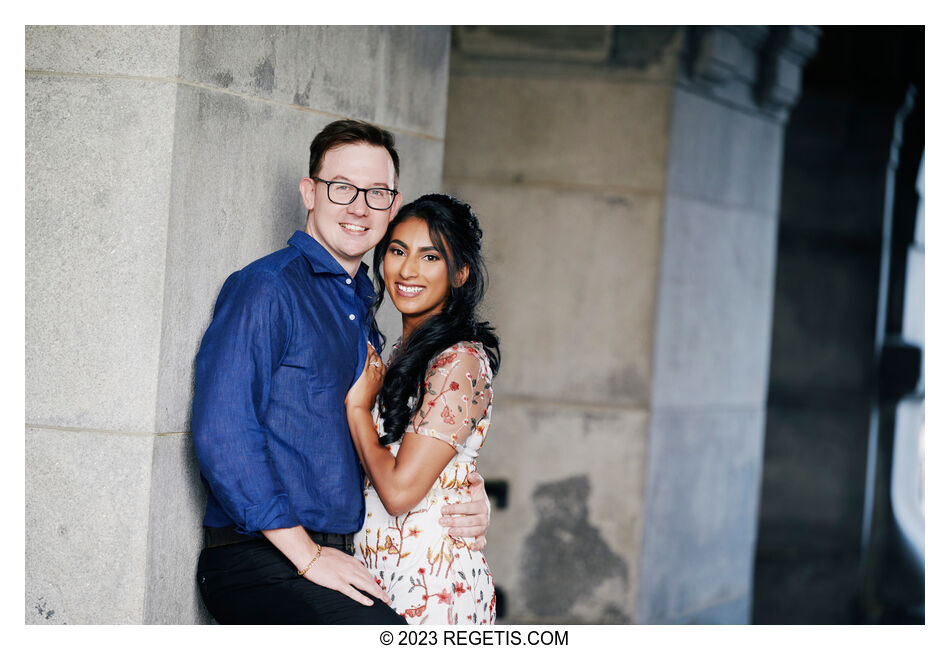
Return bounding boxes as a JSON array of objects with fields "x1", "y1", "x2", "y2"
[{"x1": 192, "y1": 272, "x2": 299, "y2": 532}]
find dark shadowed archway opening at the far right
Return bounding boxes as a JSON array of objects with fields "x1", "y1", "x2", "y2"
[{"x1": 753, "y1": 27, "x2": 924, "y2": 623}]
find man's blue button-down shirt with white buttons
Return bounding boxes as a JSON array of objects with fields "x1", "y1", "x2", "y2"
[{"x1": 192, "y1": 231, "x2": 379, "y2": 535}]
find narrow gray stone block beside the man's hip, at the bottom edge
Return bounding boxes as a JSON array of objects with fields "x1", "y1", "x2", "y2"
[{"x1": 143, "y1": 434, "x2": 211, "y2": 625}]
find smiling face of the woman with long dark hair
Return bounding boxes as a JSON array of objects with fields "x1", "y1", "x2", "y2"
[{"x1": 383, "y1": 217, "x2": 449, "y2": 333}]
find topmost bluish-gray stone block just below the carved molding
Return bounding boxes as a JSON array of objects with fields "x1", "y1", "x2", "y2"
[{"x1": 663, "y1": 88, "x2": 785, "y2": 211}]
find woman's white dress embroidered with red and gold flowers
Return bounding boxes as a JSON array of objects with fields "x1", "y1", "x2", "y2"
[{"x1": 355, "y1": 342, "x2": 495, "y2": 625}]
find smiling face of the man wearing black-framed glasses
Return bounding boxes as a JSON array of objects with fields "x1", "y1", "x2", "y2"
[{"x1": 300, "y1": 143, "x2": 402, "y2": 275}]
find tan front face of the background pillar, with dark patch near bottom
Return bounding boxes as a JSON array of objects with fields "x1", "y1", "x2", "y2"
[{"x1": 445, "y1": 27, "x2": 682, "y2": 623}]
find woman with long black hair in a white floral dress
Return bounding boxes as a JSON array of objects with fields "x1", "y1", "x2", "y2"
[{"x1": 346, "y1": 194, "x2": 499, "y2": 624}]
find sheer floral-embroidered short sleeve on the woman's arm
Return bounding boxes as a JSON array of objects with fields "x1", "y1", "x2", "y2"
[{"x1": 412, "y1": 345, "x2": 492, "y2": 450}]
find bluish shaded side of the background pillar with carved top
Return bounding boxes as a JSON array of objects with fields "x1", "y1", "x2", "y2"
[{"x1": 636, "y1": 27, "x2": 818, "y2": 624}]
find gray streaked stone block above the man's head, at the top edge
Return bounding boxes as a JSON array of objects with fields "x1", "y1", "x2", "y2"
[{"x1": 181, "y1": 25, "x2": 449, "y2": 138}]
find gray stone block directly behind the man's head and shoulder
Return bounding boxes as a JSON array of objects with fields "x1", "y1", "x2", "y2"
[{"x1": 156, "y1": 86, "x2": 452, "y2": 432}]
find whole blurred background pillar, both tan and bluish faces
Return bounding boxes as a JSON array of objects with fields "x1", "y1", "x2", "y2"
[{"x1": 444, "y1": 26, "x2": 818, "y2": 623}]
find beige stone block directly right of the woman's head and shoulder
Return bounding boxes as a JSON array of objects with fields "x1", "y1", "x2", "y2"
[{"x1": 449, "y1": 183, "x2": 660, "y2": 406}]
